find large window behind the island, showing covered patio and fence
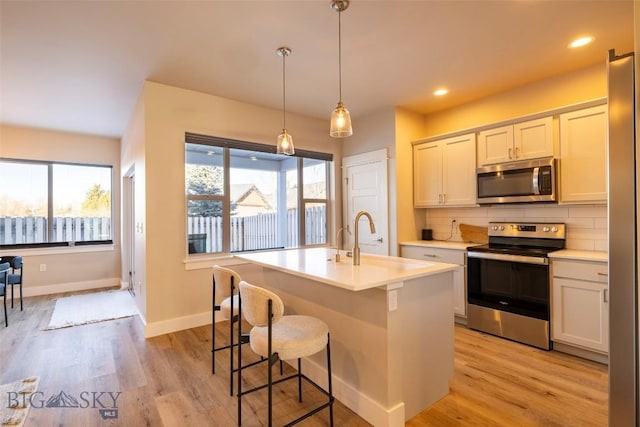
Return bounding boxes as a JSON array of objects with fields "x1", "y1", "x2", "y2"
[{"x1": 185, "y1": 133, "x2": 332, "y2": 254}]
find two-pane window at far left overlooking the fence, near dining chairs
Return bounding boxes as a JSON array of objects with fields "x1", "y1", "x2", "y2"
[{"x1": 0, "y1": 159, "x2": 112, "y2": 247}]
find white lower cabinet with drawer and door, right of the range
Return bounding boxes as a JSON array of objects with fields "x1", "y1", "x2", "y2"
[{"x1": 551, "y1": 260, "x2": 609, "y2": 354}]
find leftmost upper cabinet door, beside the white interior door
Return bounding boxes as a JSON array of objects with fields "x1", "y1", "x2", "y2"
[{"x1": 413, "y1": 142, "x2": 442, "y2": 208}]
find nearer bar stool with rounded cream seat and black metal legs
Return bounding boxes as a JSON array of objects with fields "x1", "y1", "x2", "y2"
[{"x1": 237, "y1": 281, "x2": 334, "y2": 427}]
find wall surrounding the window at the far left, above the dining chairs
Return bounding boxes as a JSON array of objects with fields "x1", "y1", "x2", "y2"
[{"x1": 0, "y1": 125, "x2": 120, "y2": 296}]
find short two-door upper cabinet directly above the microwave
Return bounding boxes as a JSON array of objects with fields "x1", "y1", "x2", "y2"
[{"x1": 478, "y1": 117, "x2": 553, "y2": 167}]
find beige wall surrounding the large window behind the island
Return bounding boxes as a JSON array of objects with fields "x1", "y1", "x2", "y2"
[{"x1": 122, "y1": 82, "x2": 342, "y2": 335}]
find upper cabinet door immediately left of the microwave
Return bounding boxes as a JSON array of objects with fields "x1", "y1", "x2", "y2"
[{"x1": 442, "y1": 134, "x2": 477, "y2": 206}]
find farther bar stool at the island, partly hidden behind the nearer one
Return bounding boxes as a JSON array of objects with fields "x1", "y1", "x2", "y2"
[{"x1": 211, "y1": 265, "x2": 243, "y2": 396}]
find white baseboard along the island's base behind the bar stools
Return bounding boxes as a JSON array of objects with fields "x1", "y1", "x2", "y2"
[{"x1": 292, "y1": 359, "x2": 405, "y2": 427}]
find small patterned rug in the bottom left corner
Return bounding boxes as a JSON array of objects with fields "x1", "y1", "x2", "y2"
[{"x1": 0, "y1": 377, "x2": 40, "y2": 427}]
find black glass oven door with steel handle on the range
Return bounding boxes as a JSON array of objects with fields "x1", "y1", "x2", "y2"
[{"x1": 467, "y1": 251, "x2": 550, "y2": 321}]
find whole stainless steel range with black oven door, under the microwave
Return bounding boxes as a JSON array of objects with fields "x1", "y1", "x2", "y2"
[{"x1": 467, "y1": 222, "x2": 565, "y2": 350}]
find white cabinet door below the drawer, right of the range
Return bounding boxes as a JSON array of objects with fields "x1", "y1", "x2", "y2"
[{"x1": 551, "y1": 277, "x2": 609, "y2": 353}]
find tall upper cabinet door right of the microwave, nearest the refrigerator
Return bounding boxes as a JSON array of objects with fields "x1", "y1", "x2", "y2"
[{"x1": 560, "y1": 105, "x2": 607, "y2": 202}]
